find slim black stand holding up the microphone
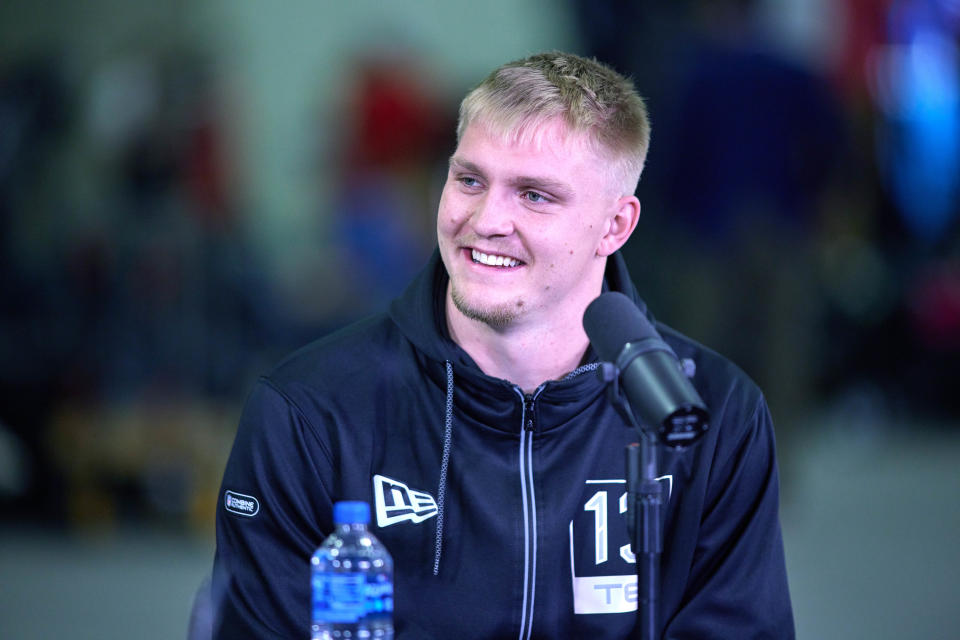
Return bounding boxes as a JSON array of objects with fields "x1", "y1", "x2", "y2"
[{"x1": 597, "y1": 362, "x2": 663, "y2": 640}]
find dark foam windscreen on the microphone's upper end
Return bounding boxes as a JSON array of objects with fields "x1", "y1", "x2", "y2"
[{"x1": 583, "y1": 291, "x2": 659, "y2": 362}]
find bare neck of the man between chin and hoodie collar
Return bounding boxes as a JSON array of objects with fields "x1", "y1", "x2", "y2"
[{"x1": 446, "y1": 291, "x2": 590, "y2": 393}]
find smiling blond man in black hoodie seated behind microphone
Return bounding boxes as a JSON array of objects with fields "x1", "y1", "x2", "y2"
[{"x1": 213, "y1": 52, "x2": 793, "y2": 639}]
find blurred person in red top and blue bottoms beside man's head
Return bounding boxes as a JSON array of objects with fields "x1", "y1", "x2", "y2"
[{"x1": 325, "y1": 48, "x2": 453, "y2": 320}]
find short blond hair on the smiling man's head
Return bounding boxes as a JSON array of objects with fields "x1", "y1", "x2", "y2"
[{"x1": 457, "y1": 51, "x2": 650, "y2": 194}]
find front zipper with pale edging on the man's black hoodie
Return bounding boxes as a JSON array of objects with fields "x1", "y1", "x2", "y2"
[{"x1": 514, "y1": 385, "x2": 545, "y2": 640}]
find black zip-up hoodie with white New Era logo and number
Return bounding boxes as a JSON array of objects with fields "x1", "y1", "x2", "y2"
[{"x1": 213, "y1": 253, "x2": 794, "y2": 640}]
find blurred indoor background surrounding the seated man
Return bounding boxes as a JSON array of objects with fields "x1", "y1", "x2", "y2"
[{"x1": 0, "y1": 0, "x2": 960, "y2": 639}]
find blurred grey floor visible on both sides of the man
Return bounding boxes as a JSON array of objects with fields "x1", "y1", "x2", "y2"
[{"x1": 0, "y1": 428, "x2": 960, "y2": 640}]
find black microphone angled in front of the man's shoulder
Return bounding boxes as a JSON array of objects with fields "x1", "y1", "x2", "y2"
[{"x1": 583, "y1": 292, "x2": 710, "y2": 447}]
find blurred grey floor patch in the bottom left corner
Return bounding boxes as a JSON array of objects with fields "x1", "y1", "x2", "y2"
[{"x1": 0, "y1": 531, "x2": 213, "y2": 640}]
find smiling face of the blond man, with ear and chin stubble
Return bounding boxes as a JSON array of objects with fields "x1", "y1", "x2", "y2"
[{"x1": 437, "y1": 121, "x2": 639, "y2": 329}]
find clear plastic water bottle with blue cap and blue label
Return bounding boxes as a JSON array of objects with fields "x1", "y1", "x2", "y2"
[{"x1": 310, "y1": 502, "x2": 393, "y2": 640}]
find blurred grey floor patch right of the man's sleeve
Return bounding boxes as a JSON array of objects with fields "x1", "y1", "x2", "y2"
[{"x1": 781, "y1": 425, "x2": 960, "y2": 640}]
